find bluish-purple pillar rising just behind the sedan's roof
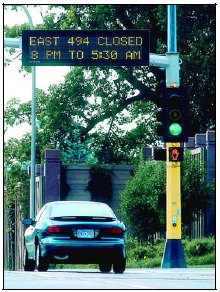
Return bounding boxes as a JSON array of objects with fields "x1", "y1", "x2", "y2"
[{"x1": 43, "y1": 149, "x2": 61, "y2": 204}]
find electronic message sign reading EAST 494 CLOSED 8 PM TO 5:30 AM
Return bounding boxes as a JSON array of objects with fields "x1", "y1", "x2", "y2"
[{"x1": 22, "y1": 30, "x2": 149, "y2": 66}]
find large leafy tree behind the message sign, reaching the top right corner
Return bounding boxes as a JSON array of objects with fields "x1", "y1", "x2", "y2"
[{"x1": 5, "y1": 4, "x2": 215, "y2": 163}]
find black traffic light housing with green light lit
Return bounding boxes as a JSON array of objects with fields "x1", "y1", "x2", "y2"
[{"x1": 157, "y1": 86, "x2": 188, "y2": 142}]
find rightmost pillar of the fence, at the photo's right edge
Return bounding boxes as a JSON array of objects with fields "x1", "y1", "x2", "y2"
[{"x1": 204, "y1": 131, "x2": 216, "y2": 236}]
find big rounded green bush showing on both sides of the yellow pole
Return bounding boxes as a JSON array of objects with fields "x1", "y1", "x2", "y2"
[{"x1": 121, "y1": 153, "x2": 211, "y2": 241}]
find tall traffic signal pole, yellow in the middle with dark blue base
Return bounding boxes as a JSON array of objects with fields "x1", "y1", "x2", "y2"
[{"x1": 161, "y1": 5, "x2": 186, "y2": 268}]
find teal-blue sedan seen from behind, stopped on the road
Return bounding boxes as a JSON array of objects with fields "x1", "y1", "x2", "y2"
[{"x1": 22, "y1": 201, "x2": 126, "y2": 273}]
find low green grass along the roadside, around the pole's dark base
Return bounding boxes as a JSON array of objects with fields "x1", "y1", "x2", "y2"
[{"x1": 51, "y1": 237, "x2": 215, "y2": 269}]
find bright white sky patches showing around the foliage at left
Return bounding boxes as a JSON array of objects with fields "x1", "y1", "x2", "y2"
[{"x1": 4, "y1": 5, "x2": 69, "y2": 140}]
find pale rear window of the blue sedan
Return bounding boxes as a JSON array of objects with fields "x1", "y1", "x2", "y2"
[{"x1": 50, "y1": 201, "x2": 115, "y2": 218}]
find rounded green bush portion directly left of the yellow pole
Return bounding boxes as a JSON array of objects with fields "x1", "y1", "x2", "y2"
[{"x1": 121, "y1": 161, "x2": 166, "y2": 241}]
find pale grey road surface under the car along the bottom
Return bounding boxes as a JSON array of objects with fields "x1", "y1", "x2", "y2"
[{"x1": 3, "y1": 268, "x2": 216, "y2": 290}]
